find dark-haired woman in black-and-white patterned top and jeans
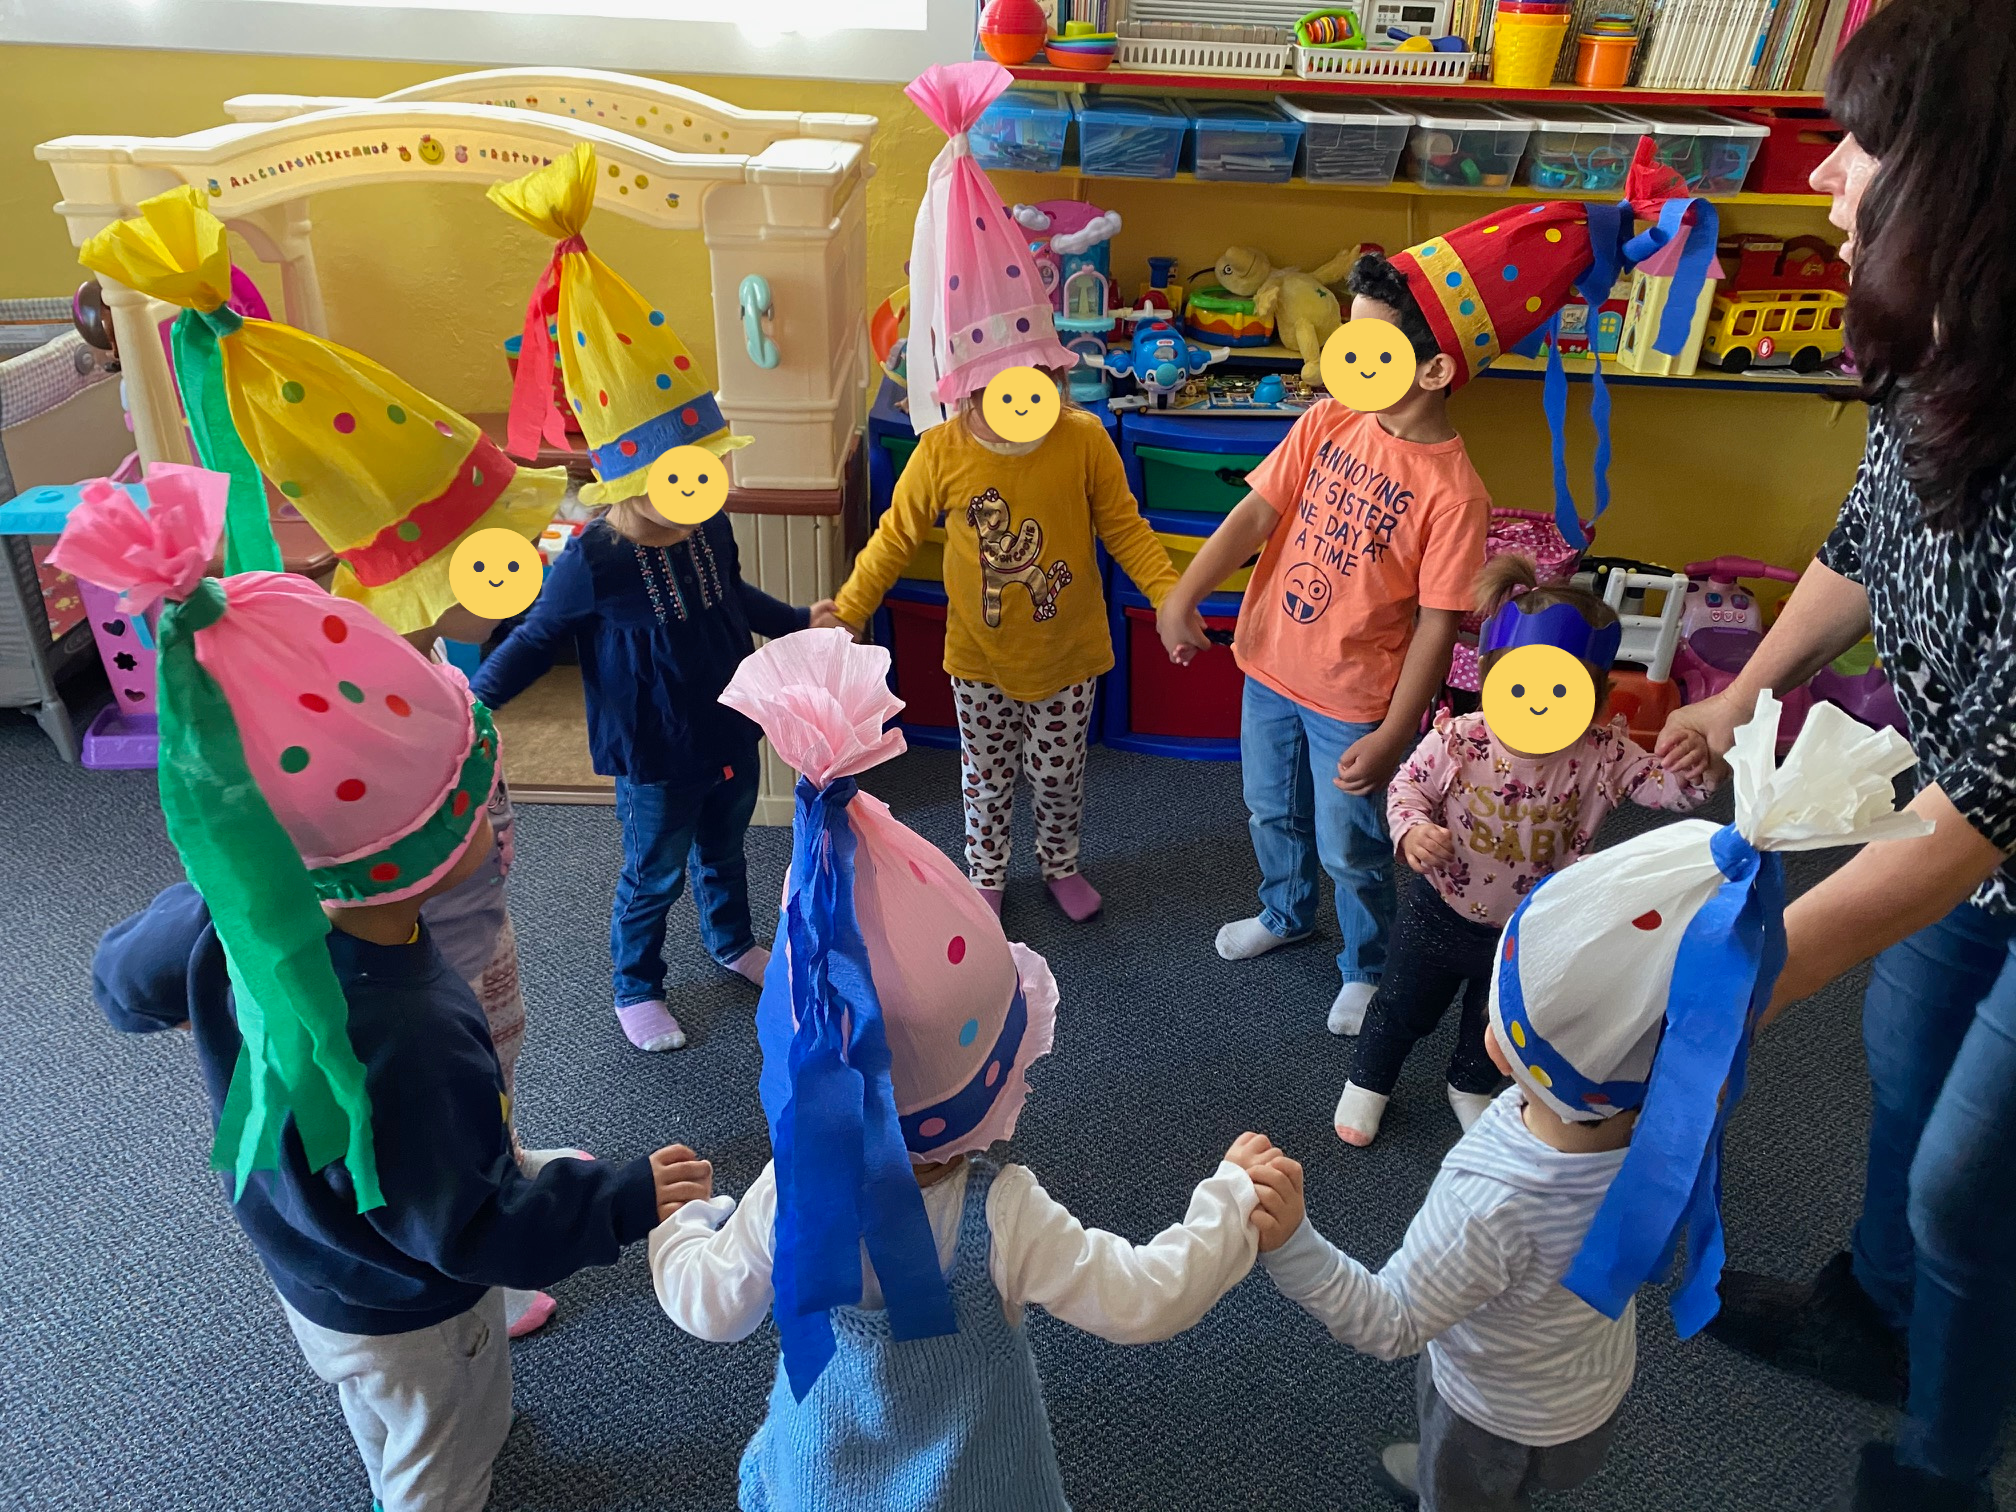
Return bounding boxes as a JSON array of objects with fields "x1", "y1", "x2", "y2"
[{"x1": 1667, "y1": 0, "x2": 2016, "y2": 1512}]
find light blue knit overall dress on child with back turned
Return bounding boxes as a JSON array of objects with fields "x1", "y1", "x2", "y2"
[{"x1": 740, "y1": 1159, "x2": 1070, "y2": 1512}]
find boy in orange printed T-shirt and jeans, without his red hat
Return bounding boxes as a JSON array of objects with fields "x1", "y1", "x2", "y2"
[{"x1": 1157, "y1": 254, "x2": 1490, "y2": 1034}]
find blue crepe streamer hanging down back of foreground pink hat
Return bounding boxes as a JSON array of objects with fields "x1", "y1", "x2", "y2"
[{"x1": 756, "y1": 776, "x2": 958, "y2": 1401}]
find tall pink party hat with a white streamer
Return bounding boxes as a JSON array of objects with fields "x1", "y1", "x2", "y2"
[{"x1": 903, "y1": 62, "x2": 1077, "y2": 403}]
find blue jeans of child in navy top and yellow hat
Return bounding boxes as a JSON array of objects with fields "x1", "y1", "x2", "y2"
[{"x1": 609, "y1": 770, "x2": 758, "y2": 1008}]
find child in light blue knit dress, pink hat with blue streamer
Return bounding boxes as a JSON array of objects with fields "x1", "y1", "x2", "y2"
[{"x1": 651, "y1": 631, "x2": 1274, "y2": 1512}]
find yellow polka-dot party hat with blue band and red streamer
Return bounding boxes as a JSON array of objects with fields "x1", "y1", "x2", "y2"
[{"x1": 490, "y1": 141, "x2": 748, "y2": 504}]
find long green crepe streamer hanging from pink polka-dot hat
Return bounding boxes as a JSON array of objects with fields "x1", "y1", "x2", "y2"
[{"x1": 155, "y1": 579, "x2": 385, "y2": 1212}]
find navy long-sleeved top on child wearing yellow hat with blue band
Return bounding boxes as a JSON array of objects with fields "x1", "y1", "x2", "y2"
[{"x1": 474, "y1": 514, "x2": 808, "y2": 786}]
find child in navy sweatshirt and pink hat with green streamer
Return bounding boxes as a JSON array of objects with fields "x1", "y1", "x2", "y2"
[{"x1": 56, "y1": 466, "x2": 706, "y2": 1512}]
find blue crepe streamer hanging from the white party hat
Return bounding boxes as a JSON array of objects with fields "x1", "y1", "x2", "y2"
[{"x1": 1560, "y1": 825, "x2": 1784, "y2": 1339}]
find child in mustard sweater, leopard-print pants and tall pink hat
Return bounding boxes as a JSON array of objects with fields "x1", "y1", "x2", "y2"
[{"x1": 835, "y1": 62, "x2": 1175, "y2": 923}]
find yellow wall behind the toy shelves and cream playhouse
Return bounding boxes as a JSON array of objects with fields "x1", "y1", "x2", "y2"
[{"x1": 0, "y1": 46, "x2": 1863, "y2": 580}]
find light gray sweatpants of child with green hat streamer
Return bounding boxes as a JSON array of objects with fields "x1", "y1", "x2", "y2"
[{"x1": 280, "y1": 1288, "x2": 510, "y2": 1512}]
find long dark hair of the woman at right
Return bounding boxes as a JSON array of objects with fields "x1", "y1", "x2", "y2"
[{"x1": 1826, "y1": 0, "x2": 2016, "y2": 530}]
